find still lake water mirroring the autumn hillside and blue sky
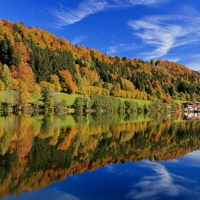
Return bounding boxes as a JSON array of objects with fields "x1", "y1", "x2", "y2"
[{"x1": 0, "y1": 114, "x2": 200, "y2": 200}]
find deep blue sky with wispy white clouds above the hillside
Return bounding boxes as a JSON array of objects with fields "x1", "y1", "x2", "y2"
[{"x1": 0, "y1": 0, "x2": 200, "y2": 71}]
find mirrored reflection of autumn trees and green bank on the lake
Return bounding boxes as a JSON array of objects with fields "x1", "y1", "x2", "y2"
[{"x1": 0, "y1": 113, "x2": 200, "y2": 198}]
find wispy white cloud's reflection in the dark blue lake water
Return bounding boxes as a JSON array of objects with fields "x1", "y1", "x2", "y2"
[{"x1": 127, "y1": 162, "x2": 200, "y2": 199}]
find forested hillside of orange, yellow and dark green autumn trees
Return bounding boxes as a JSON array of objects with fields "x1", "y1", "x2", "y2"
[{"x1": 0, "y1": 20, "x2": 200, "y2": 104}]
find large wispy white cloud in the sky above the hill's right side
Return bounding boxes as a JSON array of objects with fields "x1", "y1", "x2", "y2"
[{"x1": 128, "y1": 11, "x2": 200, "y2": 60}]
